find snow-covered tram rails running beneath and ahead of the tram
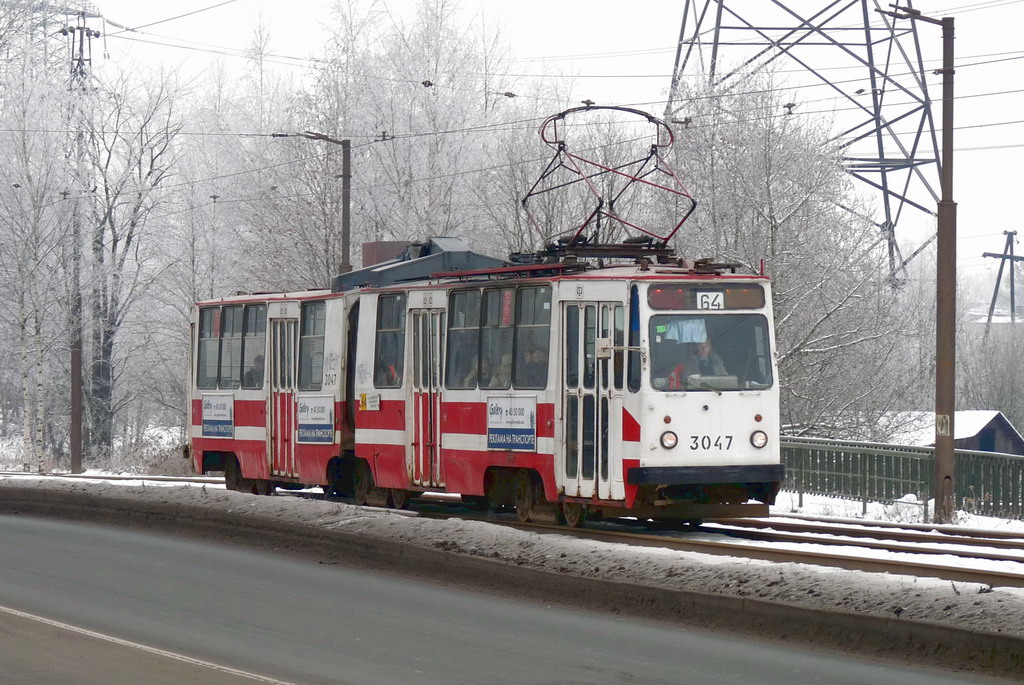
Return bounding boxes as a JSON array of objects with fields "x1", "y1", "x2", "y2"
[{"x1": 12, "y1": 472, "x2": 1024, "y2": 588}]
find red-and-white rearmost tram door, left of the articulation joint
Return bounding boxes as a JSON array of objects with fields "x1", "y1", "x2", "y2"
[{"x1": 269, "y1": 318, "x2": 299, "y2": 476}]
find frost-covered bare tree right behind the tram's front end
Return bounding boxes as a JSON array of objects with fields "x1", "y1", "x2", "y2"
[{"x1": 667, "y1": 79, "x2": 928, "y2": 437}]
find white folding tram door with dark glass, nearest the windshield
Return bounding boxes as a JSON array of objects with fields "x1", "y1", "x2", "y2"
[{"x1": 561, "y1": 302, "x2": 621, "y2": 498}]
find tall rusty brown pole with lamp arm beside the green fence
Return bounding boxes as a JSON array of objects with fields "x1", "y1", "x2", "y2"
[{"x1": 878, "y1": 5, "x2": 956, "y2": 523}]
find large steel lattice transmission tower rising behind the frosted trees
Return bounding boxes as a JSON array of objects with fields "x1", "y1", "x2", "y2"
[{"x1": 666, "y1": 0, "x2": 941, "y2": 286}]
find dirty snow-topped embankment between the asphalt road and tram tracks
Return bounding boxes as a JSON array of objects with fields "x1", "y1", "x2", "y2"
[{"x1": 0, "y1": 476, "x2": 1024, "y2": 675}]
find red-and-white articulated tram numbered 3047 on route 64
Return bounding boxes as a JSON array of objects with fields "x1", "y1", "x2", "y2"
[{"x1": 190, "y1": 243, "x2": 783, "y2": 525}]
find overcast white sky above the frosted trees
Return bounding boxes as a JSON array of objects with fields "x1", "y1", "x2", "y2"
[{"x1": 83, "y1": 0, "x2": 1024, "y2": 290}]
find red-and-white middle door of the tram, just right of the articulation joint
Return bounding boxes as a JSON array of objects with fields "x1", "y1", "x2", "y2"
[{"x1": 410, "y1": 309, "x2": 445, "y2": 487}]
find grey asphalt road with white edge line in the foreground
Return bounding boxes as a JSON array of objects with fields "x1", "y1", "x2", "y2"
[{"x1": 0, "y1": 515, "x2": 992, "y2": 685}]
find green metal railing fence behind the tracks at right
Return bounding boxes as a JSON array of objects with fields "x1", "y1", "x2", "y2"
[{"x1": 782, "y1": 437, "x2": 1024, "y2": 519}]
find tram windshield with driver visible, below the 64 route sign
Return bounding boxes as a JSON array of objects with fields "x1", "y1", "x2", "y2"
[{"x1": 650, "y1": 314, "x2": 774, "y2": 391}]
